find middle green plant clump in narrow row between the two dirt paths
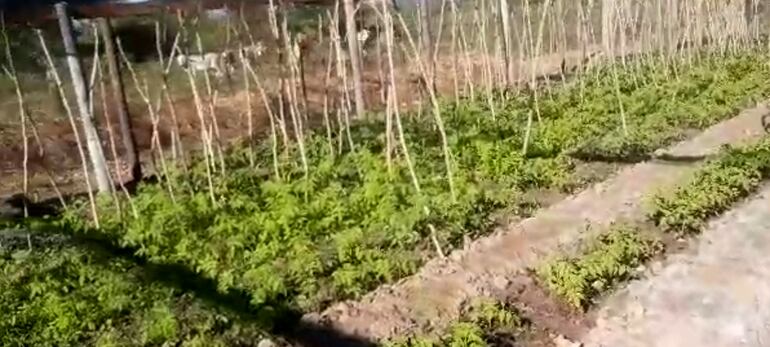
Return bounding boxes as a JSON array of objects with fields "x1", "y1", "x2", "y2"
[{"x1": 535, "y1": 225, "x2": 662, "y2": 309}]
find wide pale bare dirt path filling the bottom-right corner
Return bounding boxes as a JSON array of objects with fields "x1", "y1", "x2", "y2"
[{"x1": 584, "y1": 185, "x2": 770, "y2": 347}]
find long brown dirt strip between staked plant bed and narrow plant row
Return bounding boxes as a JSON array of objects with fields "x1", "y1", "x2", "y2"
[{"x1": 305, "y1": 106, "x2": 770, "y2": 339}]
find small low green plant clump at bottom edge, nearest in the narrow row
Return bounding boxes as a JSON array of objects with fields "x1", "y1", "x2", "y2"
[{"x1": 385, "y1": 299, "x2": 527, "y2": 347}]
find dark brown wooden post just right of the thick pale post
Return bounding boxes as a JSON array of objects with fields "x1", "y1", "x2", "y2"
[{"x1": 99, "y1": 18, "x2": 142, "y2": 181}]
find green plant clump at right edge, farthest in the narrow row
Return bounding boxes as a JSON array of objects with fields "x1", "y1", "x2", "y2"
[{"x1": 650, "y1": 140, "x2": 770, "y2": 236}]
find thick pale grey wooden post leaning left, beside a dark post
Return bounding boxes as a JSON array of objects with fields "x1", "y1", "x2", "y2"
[{"x1": 54, "y1": 2, "x2": 112, "y2": 193}]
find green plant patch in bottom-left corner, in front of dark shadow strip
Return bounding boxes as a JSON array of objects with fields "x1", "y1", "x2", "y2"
[{"x1": 0, "y1": 245, "x2": 270, "y2": 346}]
